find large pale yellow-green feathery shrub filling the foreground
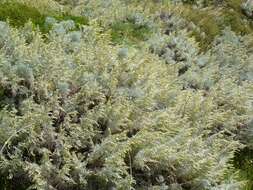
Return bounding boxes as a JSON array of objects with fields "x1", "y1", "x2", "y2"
[{"x1": 0, "y1": 20, "x2": 251, "y2": 190}]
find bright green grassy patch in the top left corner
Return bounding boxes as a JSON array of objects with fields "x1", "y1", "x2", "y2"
[{"x1": 0, "y1": 2, "x2": 88, "y2": 33}]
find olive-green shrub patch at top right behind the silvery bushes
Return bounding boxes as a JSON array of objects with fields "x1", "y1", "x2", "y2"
[{"x1": 180, "y1": 1, "x2": 253, "y2": 50}]
